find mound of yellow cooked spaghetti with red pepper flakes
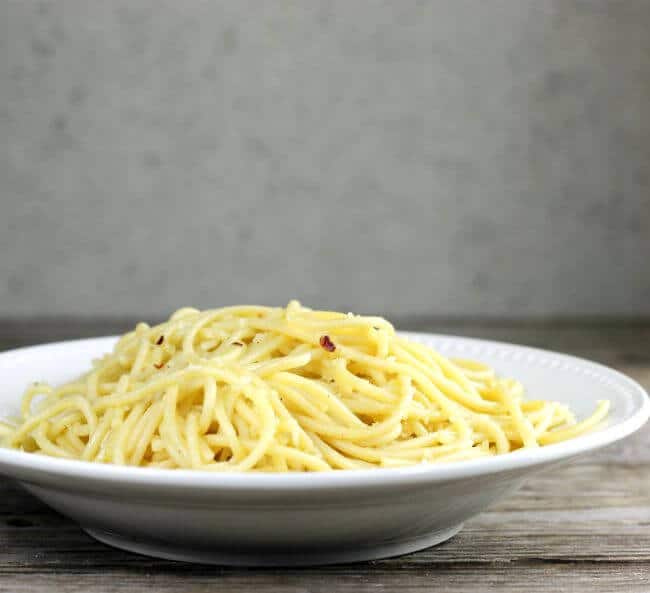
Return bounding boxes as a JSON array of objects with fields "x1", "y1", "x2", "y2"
[{"x1": 0, "y1": 301, "x2": 609, "y2": 472}]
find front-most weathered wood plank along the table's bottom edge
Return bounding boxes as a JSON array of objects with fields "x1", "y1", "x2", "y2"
[{"x1": 0, "y1": 562, "x2": 650, "y2": 593}]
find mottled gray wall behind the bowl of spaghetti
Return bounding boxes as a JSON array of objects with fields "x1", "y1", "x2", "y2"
[{"x1": 0, "y1": 0, "x2": 650, "y2": 317}]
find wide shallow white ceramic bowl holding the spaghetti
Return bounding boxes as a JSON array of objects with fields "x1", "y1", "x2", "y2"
[{"x1": 0, "y1": 334, "x2": 650, "y2": 566}]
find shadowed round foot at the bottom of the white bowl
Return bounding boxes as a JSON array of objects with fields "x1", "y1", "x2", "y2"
[{"x1": 82, "y1": 523, "x2": 463, "y2": 567}]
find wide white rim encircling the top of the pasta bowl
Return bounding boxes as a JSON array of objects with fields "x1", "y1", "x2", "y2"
[{"x1": 0, "y1": 331, "x2": 650, "y2": 491}]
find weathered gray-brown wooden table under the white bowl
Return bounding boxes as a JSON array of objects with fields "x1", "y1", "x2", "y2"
[{"x1": 0, "y1": 320, "x2": 650, "y2": 593}]
